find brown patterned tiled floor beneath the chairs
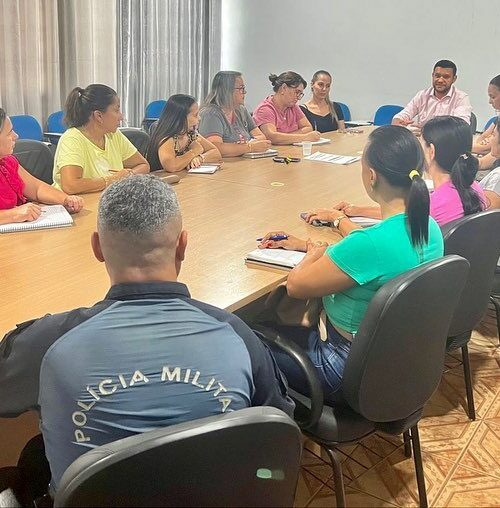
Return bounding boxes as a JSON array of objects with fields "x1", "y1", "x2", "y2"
[{"x1": 295, "y1": 309, "x2": 500, "y2": 507}]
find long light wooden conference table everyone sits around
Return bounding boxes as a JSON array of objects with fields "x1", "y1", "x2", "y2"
[{"x1": 0, "y1": 128, "x2": 373, "y2": 467}]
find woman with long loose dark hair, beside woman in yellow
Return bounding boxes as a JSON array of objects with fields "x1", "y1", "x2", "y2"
[{"x1": 146, "y1": 94, "x2": 221, "y2": 173}]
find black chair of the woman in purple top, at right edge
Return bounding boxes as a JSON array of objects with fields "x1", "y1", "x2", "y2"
[{"x1": 442, "y1": 210, "x2": 500, "y2": 420}]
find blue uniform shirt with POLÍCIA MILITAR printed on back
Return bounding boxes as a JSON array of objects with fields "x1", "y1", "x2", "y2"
[{"x1": 0, "y1": 282, "x2": 294, "y2": 488}]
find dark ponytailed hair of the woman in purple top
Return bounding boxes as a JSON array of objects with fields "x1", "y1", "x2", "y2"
[{"x1": 422, "y1": 116, "x2": 484, "y2": 215}]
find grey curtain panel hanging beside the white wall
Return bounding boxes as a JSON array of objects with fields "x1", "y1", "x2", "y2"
[{"x1": 118, "y1": 0, "x2": 221, "y2": 126}]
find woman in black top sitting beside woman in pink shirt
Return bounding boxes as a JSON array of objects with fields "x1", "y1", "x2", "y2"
[{"x1": 300, "y1": 71, "x2": 345, "y2": 132}]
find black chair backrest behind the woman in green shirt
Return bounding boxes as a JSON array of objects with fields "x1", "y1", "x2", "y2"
[{"x1": 342, "y1": 256, "x2": 469, "y2": 422}]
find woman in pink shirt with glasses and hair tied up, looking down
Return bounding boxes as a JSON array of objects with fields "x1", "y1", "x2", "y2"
[{"x1": 253, "y1": 71, "x2": 320, "y2": 145}]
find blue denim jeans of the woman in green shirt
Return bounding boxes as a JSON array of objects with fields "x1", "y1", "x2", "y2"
[{"x1": 271, "y1": 322, "x2": 351, "y2": 403}]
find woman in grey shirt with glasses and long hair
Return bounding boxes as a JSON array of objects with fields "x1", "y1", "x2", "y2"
[{"x1": 198, "y1": 71, "x2": 271, "y2": 157}]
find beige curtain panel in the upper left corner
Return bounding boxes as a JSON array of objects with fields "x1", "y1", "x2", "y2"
[{"x1": 0, "y1": 0, "x2": 117, "y2": 125}]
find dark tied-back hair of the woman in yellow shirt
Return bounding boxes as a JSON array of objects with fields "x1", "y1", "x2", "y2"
[{"x1": 64, "y1": 85, "x2": 117, "y2": 127}]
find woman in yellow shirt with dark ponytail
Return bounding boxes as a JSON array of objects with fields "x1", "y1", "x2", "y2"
[{"x1": 53, "y1": 85, "x2": 149, "y2": 194}]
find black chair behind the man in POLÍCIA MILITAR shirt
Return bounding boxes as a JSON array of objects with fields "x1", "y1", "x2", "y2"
[{"x1": 54, "y1": 407, "x2": 302, "y2": 507}]
